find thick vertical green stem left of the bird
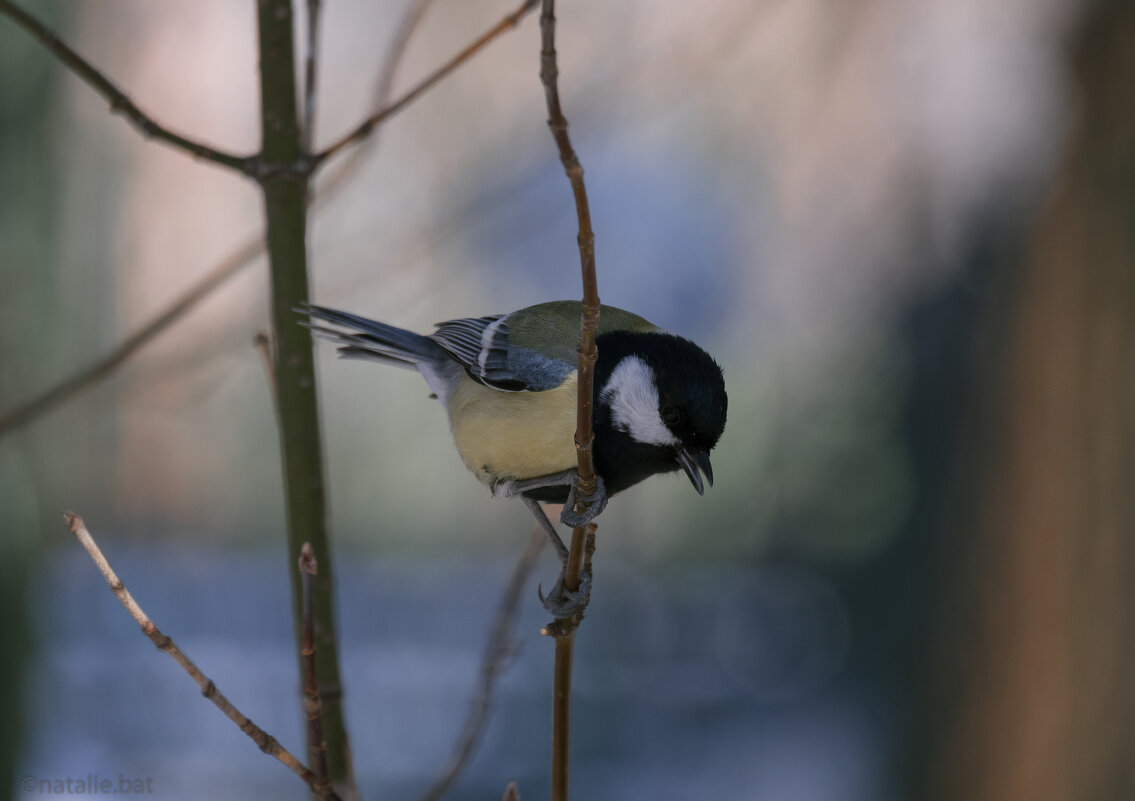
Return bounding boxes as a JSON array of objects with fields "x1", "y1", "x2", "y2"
[{"x1": 259, "y1": 0, "x2": 355, "y2": 798}]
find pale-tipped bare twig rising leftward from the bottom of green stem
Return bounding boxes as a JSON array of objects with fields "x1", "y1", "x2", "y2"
[{"x1": 64, "y1": 512, "x2": 338, "y2": 799}]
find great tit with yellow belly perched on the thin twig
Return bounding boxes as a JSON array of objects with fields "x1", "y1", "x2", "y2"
[{"x1": 297, "y1": 301, "x2": 728, "y2": 617}]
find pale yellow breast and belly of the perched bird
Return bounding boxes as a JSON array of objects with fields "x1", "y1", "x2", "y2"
[{"x1": 448, "y1": 374, "x2": 577, "y2": 486}]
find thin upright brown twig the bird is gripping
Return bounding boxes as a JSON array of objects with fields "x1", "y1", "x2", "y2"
[{"x1": 540, "y1": 0, "x2": 599, "y2": 801}]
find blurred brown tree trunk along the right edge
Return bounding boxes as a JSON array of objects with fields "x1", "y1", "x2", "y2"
[{"x1": 918, "y1": 0, "x2": 1135, "y2": 801}]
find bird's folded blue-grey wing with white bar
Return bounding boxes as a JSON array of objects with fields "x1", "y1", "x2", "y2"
[{"x1": 429, "y1": 314, "x2": 575, "y2": 393}]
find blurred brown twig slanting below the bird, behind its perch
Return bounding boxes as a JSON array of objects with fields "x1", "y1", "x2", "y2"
[{"x1": 421, "y1": 529, "x2": 548, "y2": 801}]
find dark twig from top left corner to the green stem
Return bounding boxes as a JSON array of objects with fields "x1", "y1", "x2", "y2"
[{"x1": 0, "y1": 0, "x2": 250, "y2": 175}]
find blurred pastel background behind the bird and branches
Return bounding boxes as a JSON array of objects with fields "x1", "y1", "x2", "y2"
[{"x1": 0, "y1": 0, "x2": 1135, "y2": 801}]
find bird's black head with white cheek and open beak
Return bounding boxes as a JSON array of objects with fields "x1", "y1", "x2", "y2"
[{"x1": 595, "y1": 331, "x2": 728, "y2": 495}]
